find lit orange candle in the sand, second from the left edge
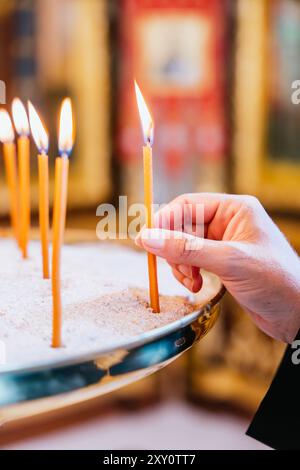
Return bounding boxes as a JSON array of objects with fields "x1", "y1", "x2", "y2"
[{"x1": 12, "y1": 98, "x2": 30, "y2": 258}]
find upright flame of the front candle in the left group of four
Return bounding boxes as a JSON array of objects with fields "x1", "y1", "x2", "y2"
[{"x1": 58, "y1": 98, "x2": 74, "y2": 155}]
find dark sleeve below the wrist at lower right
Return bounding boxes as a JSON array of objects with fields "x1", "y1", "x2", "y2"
[{"x1": 247, "y1": 334, "x2": 300, "y2": 450}]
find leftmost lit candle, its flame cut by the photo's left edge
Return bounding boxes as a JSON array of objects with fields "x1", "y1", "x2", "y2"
[{"x1": 0, "y1": 109, "x2": 19, "y2": 243}]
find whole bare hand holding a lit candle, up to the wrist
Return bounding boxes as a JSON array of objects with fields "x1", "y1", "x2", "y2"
[{"x1": 136, "y1": 193, "x2": 300, "y2": 343}]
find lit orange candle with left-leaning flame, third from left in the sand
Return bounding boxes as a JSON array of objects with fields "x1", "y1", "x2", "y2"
[{"x1": 28, "y1": 101, "x2": 49, "y2": 279}]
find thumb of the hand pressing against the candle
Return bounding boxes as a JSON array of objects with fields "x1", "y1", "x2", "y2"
[{"x1": 139, "y1": 228, "x2": 229, "y2": 276}]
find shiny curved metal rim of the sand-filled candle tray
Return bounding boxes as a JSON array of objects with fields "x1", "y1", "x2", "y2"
[{"x1": 0, "y1": 273, "x2": 225, "y2": 423}]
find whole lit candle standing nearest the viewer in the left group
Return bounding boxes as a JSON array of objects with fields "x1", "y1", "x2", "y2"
[{"x1": 52, "y1": 98, "x2": 73, "y2": 348}]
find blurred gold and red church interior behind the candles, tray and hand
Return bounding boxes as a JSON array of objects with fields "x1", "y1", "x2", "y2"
[{"x1": 0, "y1": 0, "x2": 300, "y2": 448}]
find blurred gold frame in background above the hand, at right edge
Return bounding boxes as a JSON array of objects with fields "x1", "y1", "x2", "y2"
[{"x1": 233, "y1": 0, "x2": 300, "y2": 211}]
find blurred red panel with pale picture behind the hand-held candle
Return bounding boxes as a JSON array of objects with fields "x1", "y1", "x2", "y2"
[{"x1": 118, "y1": 0, "x2": 226, "y2": 172}]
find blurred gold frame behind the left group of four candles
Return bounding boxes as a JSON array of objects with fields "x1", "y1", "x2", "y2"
[{"x1": 0, "y1": 0, "x2": 112, "y2": 215}]
